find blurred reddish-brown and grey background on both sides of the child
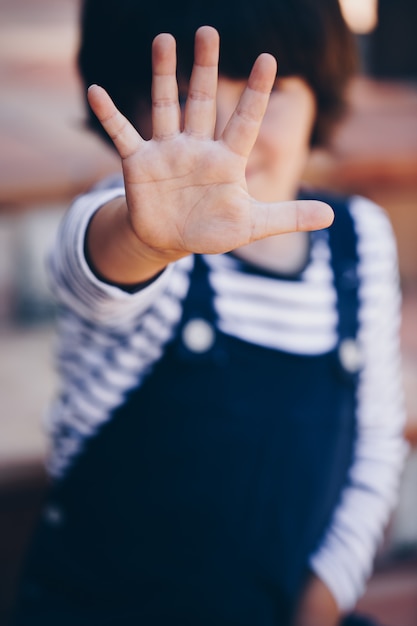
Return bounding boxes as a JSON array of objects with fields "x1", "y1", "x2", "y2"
[{"x1": 0, "y1": 0, "x2": 417, "y2": 626}]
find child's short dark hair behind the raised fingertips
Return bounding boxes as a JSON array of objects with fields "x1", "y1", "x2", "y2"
[{"x1": 78, "y1": 0, "x2": 356, "y2": 145}]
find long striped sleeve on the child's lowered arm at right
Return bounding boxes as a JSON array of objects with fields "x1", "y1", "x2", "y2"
[{"x1": 310, "y1": 197, "x2": 407, "y2": 610}]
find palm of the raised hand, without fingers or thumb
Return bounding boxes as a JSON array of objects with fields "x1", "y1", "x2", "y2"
[{"x1": 123, "y1": 133, "x2": 253, "y2": 255}]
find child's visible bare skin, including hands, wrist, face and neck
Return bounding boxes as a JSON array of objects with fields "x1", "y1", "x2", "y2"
[{"x1": 87, "y1": 27, "x2": 340, "y2": 626}]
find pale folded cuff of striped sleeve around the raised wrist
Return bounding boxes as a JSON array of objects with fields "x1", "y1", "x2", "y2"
[{"x1": 48, "y1": 186, "x2": 171, "y2": 327}]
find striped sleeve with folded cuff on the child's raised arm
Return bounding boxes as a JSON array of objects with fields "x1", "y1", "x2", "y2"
[{"x1": 45, "y1": 185, "x2": 193, "y2": 478}]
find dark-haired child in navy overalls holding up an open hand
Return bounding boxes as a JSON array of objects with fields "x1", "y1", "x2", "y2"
[{"x1": 15, "y1": 0, "x2": 404, "y2": 626}]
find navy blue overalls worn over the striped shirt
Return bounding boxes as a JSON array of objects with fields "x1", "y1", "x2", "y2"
[{"x1": 15, "y1": 194, "x2": 358, "y2": 626}]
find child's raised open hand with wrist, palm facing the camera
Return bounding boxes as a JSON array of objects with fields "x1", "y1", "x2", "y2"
[{"x1": 87, "y1": 27, "x2": 333, "y2": 285}]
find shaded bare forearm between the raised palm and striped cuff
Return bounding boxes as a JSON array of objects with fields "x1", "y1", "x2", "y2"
[{"x1": 86, "y1": 197, "x2": 171, "y2": 286}]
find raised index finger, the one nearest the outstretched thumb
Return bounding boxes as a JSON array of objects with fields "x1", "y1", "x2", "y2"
[{"x1": 221, "y1": 53, "x2": 277, "y2": 157}]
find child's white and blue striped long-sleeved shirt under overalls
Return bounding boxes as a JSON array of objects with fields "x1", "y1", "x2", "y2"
[{"x1": 44, "y1": 178, "x2": 406, "y2": 609}]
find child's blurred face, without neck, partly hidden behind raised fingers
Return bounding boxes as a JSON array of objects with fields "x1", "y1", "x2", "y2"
[{"x1": 216, "y1": 77, "x2": 316, "y2": 202}]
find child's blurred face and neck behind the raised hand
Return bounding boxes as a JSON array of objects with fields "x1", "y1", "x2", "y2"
[{"x1": 216, "y1": 77, "x2": 316, "y2": 273}]
